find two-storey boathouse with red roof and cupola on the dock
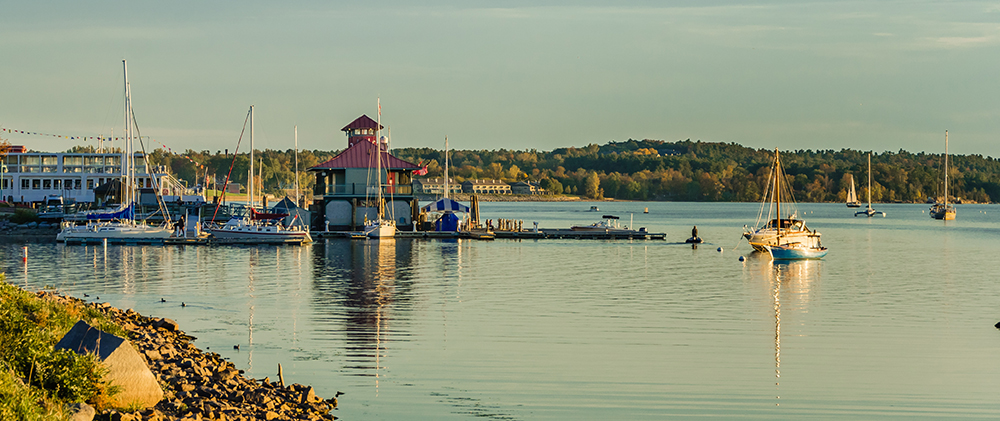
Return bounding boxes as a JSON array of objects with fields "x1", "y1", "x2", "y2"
[{"x1": 308, "y1": 115, "x2": 420, "y2": 231}]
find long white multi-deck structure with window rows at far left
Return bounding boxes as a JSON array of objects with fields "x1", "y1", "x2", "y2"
[{"x1": 0, "y1": 146, "x2": 163, "y2": 203}]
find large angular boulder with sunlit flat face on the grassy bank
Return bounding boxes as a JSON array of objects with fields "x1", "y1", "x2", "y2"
[{"x1": 56, "y1": 320, "x2": 163, "y2": 408}]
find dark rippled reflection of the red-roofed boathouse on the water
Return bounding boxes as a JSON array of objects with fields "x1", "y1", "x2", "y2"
[{"x1": 313, "y1": 239, "x2": 414, "y2": 388}]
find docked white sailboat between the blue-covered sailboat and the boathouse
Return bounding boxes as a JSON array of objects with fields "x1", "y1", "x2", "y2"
[{"x1": 207, "y1": 105, "x2": 312, "y2": 244}]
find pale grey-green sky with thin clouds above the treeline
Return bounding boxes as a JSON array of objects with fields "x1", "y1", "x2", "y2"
[{"x1": 0, "y1": 0, "x2": 1000, "y2": 157}]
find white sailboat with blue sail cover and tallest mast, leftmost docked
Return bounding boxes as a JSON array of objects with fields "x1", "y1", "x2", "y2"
[{"x1": 56, "y1": 60, "x2": 173, "y2": 243}]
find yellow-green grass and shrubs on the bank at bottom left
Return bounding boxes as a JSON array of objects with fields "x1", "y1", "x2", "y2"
[{"x1": 0, "y1": 274, "x2": 125, "y2": 420}]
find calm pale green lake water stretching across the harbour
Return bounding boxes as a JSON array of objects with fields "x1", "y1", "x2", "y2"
[{"x1": 0, "y1": 203, "x2": 1000, "y2": 420}]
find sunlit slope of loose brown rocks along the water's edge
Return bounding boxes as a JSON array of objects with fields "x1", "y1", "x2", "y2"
[{"x1": 37, "y1": 291, "x2": 337, "y2": 421}]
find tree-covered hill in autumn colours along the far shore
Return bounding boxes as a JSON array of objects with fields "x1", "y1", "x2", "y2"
[{"x1": 133, "y1": 140, "x2": 1000, "y2": 203}]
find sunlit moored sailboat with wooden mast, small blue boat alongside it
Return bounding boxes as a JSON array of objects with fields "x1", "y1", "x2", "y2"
[{"x1": 743, "y1": 148, "x2": 827, "y2": 260}]
